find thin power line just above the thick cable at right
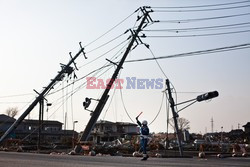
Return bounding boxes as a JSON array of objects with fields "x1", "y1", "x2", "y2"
[{"x1": 144, "y1": 30, "x2": 250, "y2": 38}]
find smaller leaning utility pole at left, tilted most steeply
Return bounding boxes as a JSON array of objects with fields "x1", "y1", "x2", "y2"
[{"x1": 0, "y1": 42, "x2": 86, "y2": 143}]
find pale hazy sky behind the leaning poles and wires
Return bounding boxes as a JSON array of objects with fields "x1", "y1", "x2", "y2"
[{"x1": 0, "y1": 0, "x2": 250, "y2": 133}]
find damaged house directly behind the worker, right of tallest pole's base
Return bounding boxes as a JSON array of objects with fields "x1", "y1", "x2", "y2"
[{"x1": 89, "y1": 120, "x2": 139, "y2": 143}]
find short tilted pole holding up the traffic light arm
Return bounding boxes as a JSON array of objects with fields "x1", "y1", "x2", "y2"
[{"x1": 166, "y1": 79, "x2": 183, "y2": 157}]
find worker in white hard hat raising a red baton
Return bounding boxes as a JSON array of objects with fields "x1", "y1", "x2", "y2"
[{"x1": 136, "y1": 116, "x2": 149, "y2": 161}]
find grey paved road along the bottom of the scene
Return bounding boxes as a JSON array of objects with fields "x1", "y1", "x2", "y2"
[{"x1": 0, "y1": 152, "x2": 250, "y2": 167}]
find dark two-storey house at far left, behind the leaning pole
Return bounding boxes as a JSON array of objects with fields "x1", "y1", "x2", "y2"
[{"x1": 0, "y1": 114, "x2": 78, "y2": 144}]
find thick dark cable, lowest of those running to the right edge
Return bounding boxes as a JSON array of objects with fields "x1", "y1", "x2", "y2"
[{"x1": 125, "y1": 43, "x2": 250, "y2": 63}]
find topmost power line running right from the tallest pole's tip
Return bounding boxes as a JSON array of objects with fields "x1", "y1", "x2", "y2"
[{"x1": 151, "y1": 0, "x2": 250, "y2": 9}]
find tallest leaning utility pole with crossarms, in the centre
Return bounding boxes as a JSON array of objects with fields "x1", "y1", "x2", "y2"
[{"x1": 79, "y1": 7, "x2": 152, "y2": 142}]
